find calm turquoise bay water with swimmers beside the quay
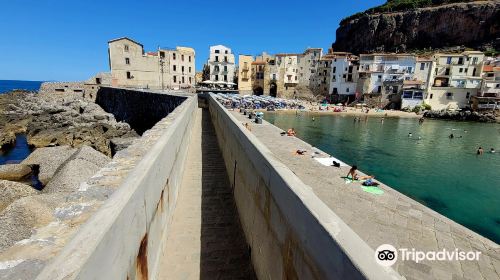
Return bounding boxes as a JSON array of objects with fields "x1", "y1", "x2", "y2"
[{"x1": 264, "y1": 112, "x2": 500, "y2": 244}]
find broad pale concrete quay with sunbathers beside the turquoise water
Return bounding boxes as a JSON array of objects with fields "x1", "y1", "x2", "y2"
[{"x1": 231, "y1": 111, "x2": 500, "y2": 280}]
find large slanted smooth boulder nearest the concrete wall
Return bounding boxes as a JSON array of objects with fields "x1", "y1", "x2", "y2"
[{"x1": 43, "y1": 146, "x2": 111, "y2": 193}]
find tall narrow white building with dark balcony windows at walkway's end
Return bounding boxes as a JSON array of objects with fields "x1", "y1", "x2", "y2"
[{"x1": 207, "y1": 45, "x2": 235, "y2": 84}]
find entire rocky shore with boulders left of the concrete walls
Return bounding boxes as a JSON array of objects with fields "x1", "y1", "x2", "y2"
[{"x1": 0, "y1": 88, "x2": 139, "y2": 264}]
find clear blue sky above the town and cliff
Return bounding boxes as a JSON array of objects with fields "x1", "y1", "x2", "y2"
[{"x1": 0, "y1": 0, "x2": 385, "y2": 81}]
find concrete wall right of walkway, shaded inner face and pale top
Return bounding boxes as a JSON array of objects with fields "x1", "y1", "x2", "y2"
[{"x1": 209, "y1": 97, "x2": 400, "y2": 279}]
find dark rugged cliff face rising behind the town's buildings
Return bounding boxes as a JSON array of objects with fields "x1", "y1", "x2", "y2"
[{"x1": 332, "y1": 0, "x2": 500, "y2": 53}]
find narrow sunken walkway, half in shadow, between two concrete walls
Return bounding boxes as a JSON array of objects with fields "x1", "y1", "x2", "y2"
[{"x1": 159, "y1": 109, "x2": 255, "y2": 280}]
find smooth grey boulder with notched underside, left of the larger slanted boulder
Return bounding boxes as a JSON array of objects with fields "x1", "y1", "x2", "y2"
[{"x1": 21, "y1": 146, "x2": 77, "y2": 185}]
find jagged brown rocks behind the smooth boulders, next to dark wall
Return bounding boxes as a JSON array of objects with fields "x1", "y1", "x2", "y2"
[{"x1": 0, "y1": 89, "x2": 138, "y2": 156}]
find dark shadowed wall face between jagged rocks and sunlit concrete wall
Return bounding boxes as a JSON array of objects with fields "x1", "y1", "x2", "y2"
[{"x1": 96, "y1": 87, "x2": 186, "y2": 134}]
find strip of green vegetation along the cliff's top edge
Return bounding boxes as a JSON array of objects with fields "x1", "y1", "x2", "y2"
[{"x1": 340, "y1": 0, "x2": 478, "y2": 25}]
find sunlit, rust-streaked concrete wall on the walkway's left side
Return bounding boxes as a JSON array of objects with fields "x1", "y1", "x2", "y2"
[{"x1": 36, "y1": 94, "x2": 197, "y2": 280}]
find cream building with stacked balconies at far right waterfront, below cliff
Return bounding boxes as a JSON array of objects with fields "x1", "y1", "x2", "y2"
[{"x1": 424, "y1": 51, "x2": 484, "y2": 110}]
